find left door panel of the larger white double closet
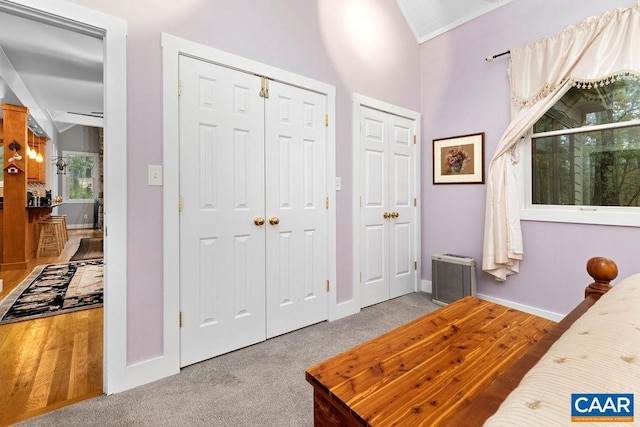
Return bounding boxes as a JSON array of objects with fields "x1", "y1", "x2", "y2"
[{"x1": 179, "y1": 57, "x2": 265, "y2": 366}]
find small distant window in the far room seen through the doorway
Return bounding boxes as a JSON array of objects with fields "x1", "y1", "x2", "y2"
[{"x1": 62, "y1": 151, "x2": 98, "y2": 203}]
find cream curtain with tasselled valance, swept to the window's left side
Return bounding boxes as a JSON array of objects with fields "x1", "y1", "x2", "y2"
[{"x1": 482, "y1": 3, "x2": 640, "y2": 280}]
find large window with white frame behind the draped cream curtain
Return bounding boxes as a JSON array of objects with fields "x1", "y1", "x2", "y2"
[{"x1": 522, "y1": 79, "x2": 640, "y2": 225}]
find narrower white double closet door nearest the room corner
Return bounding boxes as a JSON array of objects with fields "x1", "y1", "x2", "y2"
[{"x1": 359, "y1": 106, "x2": 417, "y2": 307}]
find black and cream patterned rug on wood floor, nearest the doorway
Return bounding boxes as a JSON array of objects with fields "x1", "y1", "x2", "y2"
[{"x1": 0, "y1": 260, "x2": 104, "y2": 324}]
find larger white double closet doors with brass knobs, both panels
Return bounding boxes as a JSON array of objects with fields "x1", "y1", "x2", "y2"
[{"x1": 179, "y1": 56, "x2": 328, "y2": 366}]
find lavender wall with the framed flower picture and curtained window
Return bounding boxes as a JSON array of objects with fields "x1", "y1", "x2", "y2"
[{"x1": 420, "y1": 0, "x2": 640, "y2": 313}]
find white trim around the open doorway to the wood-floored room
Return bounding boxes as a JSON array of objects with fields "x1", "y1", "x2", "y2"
[{"x1": 0, "y1": 0, "x2": 129, "y2": 393}]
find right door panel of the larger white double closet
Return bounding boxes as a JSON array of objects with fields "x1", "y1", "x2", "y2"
[{"x1": 265, "y1": 82, "x2": 327, "y2": 337}]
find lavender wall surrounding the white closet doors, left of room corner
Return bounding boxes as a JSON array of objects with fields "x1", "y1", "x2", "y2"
[{"x1": 67, "y1": 0, "x2": 420, "y2": 363}]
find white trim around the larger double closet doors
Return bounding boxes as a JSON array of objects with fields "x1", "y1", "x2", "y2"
[{"x1": 162, "y1": 33, "x2": 336, "y2": 372}]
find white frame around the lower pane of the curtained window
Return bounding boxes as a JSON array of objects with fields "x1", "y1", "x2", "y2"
[{"x1": 515, "y1": 120, "x2": 640, "y2": 227}]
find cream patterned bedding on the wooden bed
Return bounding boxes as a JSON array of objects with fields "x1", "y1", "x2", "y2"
[{"x1": 485, "y1": 274, "x2": 640, "y2": 427}]
